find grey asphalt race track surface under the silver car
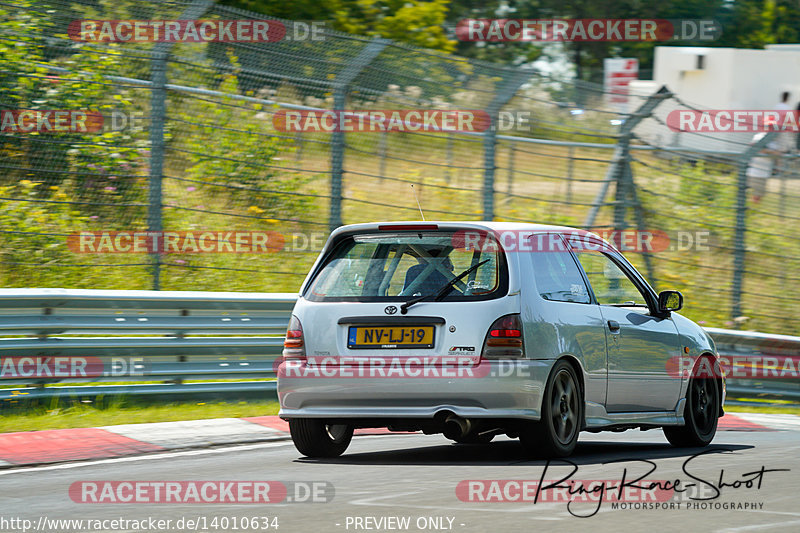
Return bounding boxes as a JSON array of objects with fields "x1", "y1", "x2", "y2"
[{"x1": 0, "y1": 429, "x2": 800, "y2": 533}]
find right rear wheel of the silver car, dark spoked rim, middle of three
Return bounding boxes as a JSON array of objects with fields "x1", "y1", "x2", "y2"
[{"x1": 519, "y1": 359, "x2": 583, "y2": 457}]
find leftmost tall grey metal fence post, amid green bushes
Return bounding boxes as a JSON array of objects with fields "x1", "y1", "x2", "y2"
[{"x1": 147, "y1": 0, "x2": 214, "y2": 291}]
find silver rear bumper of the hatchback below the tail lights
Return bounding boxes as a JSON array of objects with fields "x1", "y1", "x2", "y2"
[{"x1": 278, "y1": 359, "x2": 554, "y2": 420}]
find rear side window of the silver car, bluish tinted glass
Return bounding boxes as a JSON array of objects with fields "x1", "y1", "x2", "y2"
[{"x1": 530, "y1": 246, "x2": 591, "y2": 304}]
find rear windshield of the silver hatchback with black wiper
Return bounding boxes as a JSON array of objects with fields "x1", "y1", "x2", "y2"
[{"x1": 303, "y1": 231, "x2": 508, "y2": 302}]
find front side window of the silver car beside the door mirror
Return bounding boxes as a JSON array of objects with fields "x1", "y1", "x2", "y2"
[{"x1": 576, "y1": 250, "x2": 647, "y2": 307}]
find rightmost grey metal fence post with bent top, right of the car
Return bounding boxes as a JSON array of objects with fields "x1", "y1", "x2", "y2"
[{"x1": 731, "y1": 131, "x2": 777, "y2": 319}]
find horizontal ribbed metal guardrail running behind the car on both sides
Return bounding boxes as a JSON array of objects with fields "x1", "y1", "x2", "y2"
[{"x1": 0, "y1": 289, "x2": 800, "y2": 402}]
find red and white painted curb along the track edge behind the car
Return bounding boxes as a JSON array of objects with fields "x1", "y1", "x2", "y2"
[{"x1": 0, "y1": 413, "x2": 800, "y2": 468}]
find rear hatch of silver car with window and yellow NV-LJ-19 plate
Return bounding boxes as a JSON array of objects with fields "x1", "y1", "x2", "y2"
[{"x1": 295, "y1": 224, "x2": 519, "y2": 367}]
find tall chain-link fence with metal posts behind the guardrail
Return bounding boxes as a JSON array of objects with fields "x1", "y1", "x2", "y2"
[{"x1": 0, "y1": 0, "x2": 800, "y2": 333}]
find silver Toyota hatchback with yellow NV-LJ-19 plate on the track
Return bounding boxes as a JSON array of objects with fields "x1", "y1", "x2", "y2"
[{"x1": 278, "y1": 222, "x2": 725, "y2": 457}]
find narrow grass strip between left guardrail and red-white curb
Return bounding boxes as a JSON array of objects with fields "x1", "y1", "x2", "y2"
[{"x1": 0, "y1": 402, "x2": 278, "y2": 433}]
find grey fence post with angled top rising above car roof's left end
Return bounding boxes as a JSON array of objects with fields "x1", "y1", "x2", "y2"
[{"x1": 328, "y1": 38, "x2": 390, "y2": 231}]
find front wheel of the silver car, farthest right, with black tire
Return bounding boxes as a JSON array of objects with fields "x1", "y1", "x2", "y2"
[{"x1": 664, "y1": 377, "x2": 719, "y2": 447}]
